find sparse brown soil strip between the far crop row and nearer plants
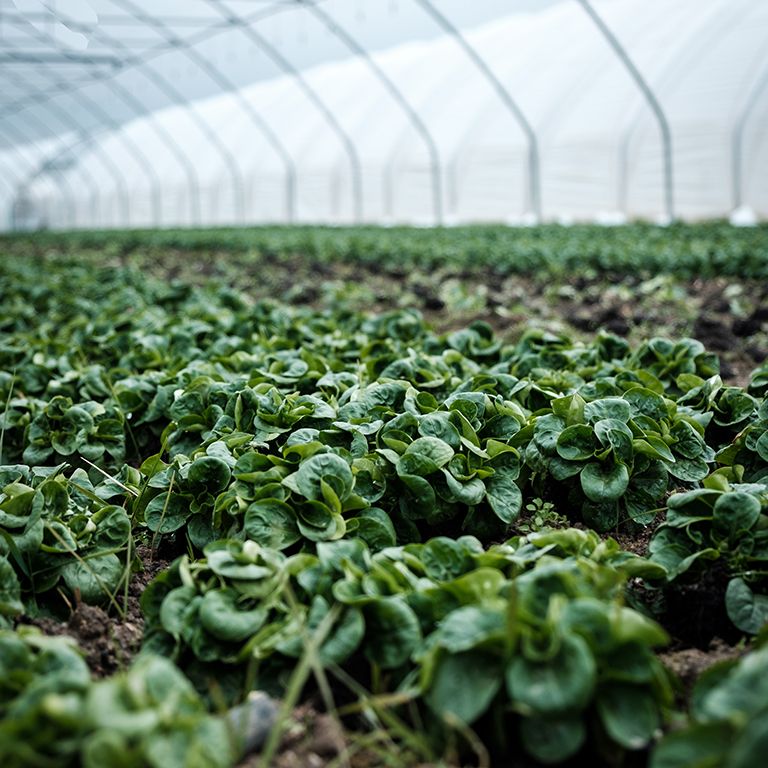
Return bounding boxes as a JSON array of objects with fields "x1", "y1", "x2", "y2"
[{"x1": 189, "y1": 254, "x2": 768, "y2": 386}]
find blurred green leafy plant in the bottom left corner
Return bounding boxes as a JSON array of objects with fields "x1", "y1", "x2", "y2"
[{"x1": 0, "y1": 628, "x2": 236, "y2": 768}]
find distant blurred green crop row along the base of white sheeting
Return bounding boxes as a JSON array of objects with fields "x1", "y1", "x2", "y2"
[{"x1": 0, "y1": 222, "x2": 768, "y2": 279}]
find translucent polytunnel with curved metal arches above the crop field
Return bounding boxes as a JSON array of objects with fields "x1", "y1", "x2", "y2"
[{"x1": 0, "y1": 0, "x2": 768, "y2": 229}]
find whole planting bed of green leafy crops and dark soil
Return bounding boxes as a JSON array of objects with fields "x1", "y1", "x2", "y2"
[{"x1": 0, "y1": 225, "x2": 768, "y2": 768}]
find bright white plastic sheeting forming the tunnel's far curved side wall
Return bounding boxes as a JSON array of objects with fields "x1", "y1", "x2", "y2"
[{"x1": 6, "y1": 0, "x2": 768, "y2": 227}]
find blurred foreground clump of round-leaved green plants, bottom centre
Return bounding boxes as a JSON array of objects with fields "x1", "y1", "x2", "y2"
[{"x1": 142, "y1": 529, "x2": 671, "y2": 762}]
